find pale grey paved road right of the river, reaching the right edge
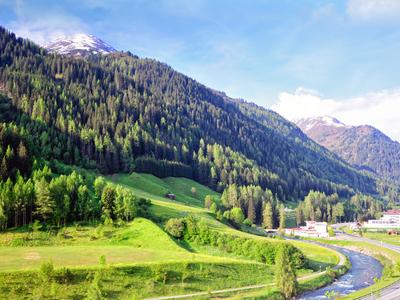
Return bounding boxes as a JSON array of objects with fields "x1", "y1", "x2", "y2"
[{"x1": 332, "y1": 223, "x2": 400, "y2": 300}]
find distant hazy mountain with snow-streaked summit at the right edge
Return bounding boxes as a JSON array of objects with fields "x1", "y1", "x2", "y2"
[{"x1": 296, "y1": 116, "x2": 400, "y2": 181}]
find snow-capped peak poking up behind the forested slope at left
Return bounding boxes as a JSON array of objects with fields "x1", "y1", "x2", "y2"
[{"x1": 45, "y1": 33, "x2": 116, "y2": 56}]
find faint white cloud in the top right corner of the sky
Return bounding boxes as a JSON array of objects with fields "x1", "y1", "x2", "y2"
[{"x1": 347, "y1": 0, "x2": 400, "y2": 20}]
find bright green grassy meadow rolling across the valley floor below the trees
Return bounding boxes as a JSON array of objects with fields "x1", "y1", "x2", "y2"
[{"x1": 0, "y1": 173, "x2": 344, "y2": 299}]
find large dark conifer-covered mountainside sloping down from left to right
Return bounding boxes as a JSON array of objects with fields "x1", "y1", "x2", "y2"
[{"x1": 0, "y1": 29, "x2": 376, "y2": 200}]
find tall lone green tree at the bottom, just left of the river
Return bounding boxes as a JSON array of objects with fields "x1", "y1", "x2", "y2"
[{"x1": 275, "y1": 245, "x2": 297, "y2": 299}]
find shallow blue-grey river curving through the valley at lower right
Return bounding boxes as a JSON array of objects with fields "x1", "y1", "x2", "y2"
[{"x1": 297, "y1": 247, "x2": 382, "y2": 299}]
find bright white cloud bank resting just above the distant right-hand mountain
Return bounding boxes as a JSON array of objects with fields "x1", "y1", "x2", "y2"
[{"x1": 271, "y1": 88, "x2": 400, "y2": 141}]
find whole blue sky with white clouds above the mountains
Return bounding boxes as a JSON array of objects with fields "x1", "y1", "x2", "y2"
[{"x1": 0, "y1": 0, "x2": 400, "y2": 141}]
